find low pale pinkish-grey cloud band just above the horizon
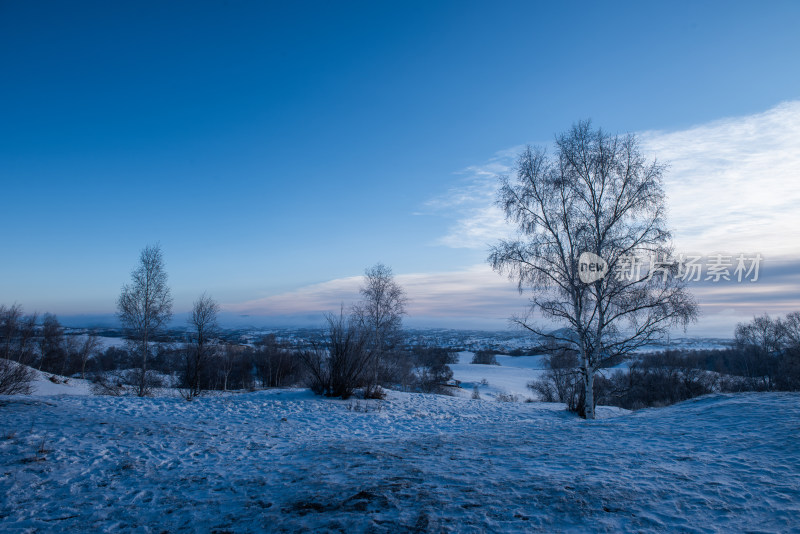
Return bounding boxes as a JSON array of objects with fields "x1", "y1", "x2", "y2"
[{"x1": 224, "y1": 257, "x2": 800, "y2": 337}]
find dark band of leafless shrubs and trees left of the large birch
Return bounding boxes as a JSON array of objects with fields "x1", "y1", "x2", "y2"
[{"x1": 0, "y1": 303, "x2": 457, "y2": 398}]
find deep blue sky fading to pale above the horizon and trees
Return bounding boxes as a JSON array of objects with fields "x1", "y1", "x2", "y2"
[{"x1": 0, "y1": 0, "x2": 800, "y2": 331}]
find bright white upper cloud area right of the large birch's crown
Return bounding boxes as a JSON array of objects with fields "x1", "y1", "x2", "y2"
[{"x1": 640, "y1": 101, "x2": 800, "y2": 255}]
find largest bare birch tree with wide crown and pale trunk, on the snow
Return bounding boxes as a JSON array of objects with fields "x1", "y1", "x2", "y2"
[{"x1": 489, "y1": 121, "x2": 697, "y2": 418}]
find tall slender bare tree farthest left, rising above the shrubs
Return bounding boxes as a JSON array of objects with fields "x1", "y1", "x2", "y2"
[{"x1": 117, "y1": 245, "x2": 172, "y2": 396}]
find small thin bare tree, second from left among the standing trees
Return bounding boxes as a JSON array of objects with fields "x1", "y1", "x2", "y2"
[{"x1": 184, "y1": 293, "x2": 219, "y2": 398}]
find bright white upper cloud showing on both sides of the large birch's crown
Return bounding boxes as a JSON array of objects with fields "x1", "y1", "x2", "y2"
[{"x1": 434, "y1": 101, "x2": 800, "y2": 255}]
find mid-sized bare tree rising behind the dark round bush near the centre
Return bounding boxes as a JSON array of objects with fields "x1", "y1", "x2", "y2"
[{"x1": 353, "y1": 263, "x2": 408, "y2": 383}]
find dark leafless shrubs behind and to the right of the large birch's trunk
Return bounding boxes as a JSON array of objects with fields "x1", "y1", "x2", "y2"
[{"x1": 529, "y1": 312, "x2": 800, "y2": 413}]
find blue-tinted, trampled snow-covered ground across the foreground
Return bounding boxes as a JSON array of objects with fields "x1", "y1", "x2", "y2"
[{"x1": 0, "y1": 386, "x2": 800, "y2": 532}]
